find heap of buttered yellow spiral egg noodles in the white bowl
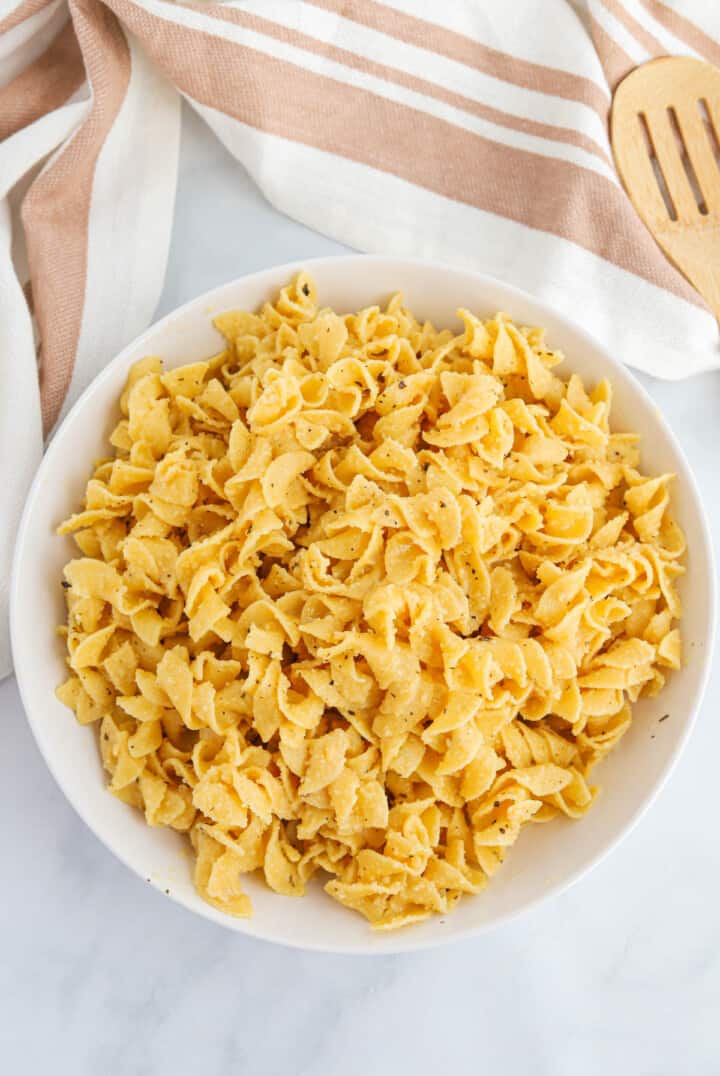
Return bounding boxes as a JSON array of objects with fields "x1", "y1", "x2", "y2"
[{"x1": 57, "y1": 273, "x2": 684, "y2": 930}]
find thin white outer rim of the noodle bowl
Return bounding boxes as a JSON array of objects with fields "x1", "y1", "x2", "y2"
[{"x1": 10, "y1": 253, "x2": 717, "y2": 957}]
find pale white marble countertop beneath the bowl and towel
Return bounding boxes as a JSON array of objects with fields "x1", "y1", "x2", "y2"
[{"x1": 0, "y1": 107, "x2": 720, "y2": 1076}]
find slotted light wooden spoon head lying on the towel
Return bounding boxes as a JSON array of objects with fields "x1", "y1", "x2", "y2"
[{"x1": 610, "y1": 56, "x2": 720, "y2": 320}]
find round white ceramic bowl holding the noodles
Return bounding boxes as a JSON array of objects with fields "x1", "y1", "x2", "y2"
[{"x1": 11, "y1": 256, "x2": 715, "y2": 953}]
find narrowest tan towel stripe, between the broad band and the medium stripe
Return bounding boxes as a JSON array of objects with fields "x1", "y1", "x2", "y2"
[{"x1": 198, "y1": 3, "x2": 612, "y2": 167}]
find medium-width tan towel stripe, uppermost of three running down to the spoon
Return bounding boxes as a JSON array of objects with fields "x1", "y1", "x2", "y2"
[{"x1": 306, "y1": 0, "x2": 610, "y2": 119}]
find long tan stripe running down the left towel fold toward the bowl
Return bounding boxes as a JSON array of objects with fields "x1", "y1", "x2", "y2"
[{"x1": 22, "y1": 0, "x2": 130, "y2": 431}]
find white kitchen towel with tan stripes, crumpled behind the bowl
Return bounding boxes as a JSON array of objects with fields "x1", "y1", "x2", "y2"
[{"x1": 0, "y1": 0, "x2": 720, "y2": 671}]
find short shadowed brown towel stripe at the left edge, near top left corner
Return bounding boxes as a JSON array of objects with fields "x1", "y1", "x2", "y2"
[{"x1": 0, "y1": 20, "x2": 85, "y2": 142}]
